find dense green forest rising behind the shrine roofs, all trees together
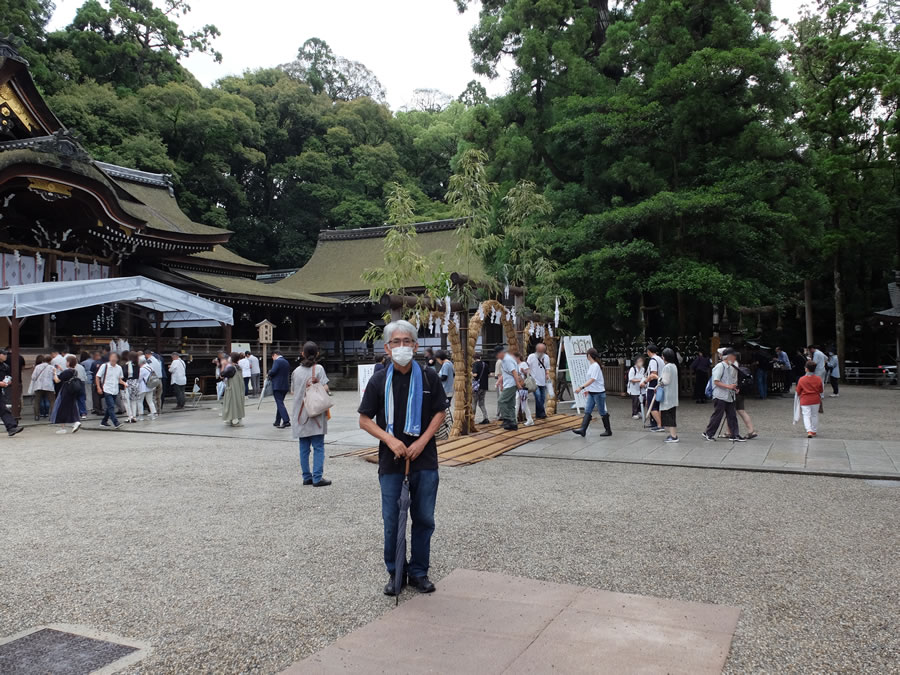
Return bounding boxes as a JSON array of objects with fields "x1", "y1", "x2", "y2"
[{"x1": 0, "y1": 0, "x2": 900, "y2": 362}]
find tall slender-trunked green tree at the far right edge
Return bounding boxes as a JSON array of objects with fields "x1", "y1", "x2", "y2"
[{"x1": 789, "y1": 0, "x2": 900, "y2": 368}]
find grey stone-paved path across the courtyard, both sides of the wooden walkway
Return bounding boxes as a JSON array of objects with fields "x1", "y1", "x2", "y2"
[{"x1": 52, "y1": 391, "x2": 900, "y2": 479}]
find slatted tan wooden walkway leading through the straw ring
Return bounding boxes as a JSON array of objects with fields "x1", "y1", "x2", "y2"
[{"x1": 332, "y1": 415, "x2": 581, "y2": 466}]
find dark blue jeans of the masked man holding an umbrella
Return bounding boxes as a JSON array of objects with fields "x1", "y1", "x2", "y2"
[{"x1": 378, "y1": 469, "x2": 439, "y2": 577}]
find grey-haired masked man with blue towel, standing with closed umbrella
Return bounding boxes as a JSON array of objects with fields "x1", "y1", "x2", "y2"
[{"x1": 358, "y1": 321, "x2": 447, "y2": 595}]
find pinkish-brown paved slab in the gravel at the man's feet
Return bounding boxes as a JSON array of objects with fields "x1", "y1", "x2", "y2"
[{"x1": 283, "y1": 569, "x2": 740, "y2": 675}]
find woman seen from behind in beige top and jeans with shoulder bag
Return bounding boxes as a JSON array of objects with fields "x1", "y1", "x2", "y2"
[{"x1": 291, "y1": 342, "x2": 331, "y2": 487}]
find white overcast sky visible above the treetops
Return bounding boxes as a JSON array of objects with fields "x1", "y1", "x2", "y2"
[{"x1": 51, "y1": 0, "x2": 801, "y2": 110}]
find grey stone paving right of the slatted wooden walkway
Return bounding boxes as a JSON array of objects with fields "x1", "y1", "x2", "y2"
[{"x1": 506, "y1": 430, "x2": 900, "y2": 479}]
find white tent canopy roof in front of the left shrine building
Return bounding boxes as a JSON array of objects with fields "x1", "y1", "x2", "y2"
[{"x1": 0, "y1": 277, "x2": 234, "y2": 329}]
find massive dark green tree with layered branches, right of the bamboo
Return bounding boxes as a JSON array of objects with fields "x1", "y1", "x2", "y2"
[{"x1": 459, "y1": 0, "x2": 809, "y2": 334}]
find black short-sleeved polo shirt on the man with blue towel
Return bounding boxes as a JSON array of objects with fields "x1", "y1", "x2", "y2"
[{"x1": 357, "y1": 368, "x2": 447, "y2": 475}]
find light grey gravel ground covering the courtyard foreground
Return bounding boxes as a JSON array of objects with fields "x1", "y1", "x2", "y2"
[{"x1": 0, "y1": 426, "x2": 900, "y2": 673}]
